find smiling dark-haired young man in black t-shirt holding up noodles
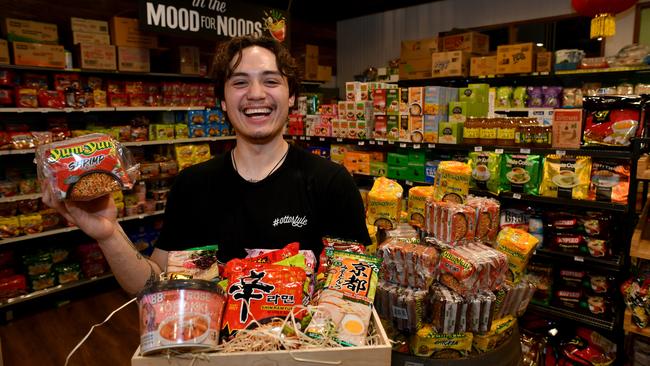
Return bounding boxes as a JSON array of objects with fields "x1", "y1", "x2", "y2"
[{"x1": 43, "y1": 37, "x2": 370, "y2": 293}]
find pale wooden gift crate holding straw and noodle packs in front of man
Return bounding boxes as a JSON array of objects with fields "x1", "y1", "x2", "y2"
[{"x1": 131, "y1": 310, "x2": 391, "y2": 366}]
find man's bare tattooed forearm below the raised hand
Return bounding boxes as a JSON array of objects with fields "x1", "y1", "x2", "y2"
[{"x1": 99, "y1": 224, "x2": 162, "y2": 294}]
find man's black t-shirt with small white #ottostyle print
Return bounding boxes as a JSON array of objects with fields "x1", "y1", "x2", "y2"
[{"x1": 157, "y1": 147, "x2": 370, "y2": 261}]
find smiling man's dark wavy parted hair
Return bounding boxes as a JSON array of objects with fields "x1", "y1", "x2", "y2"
[{"x1": 212, "y1": 36, "x2": 300, "y2": 100}]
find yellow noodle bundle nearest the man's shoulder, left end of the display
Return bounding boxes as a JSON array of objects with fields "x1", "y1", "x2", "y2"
[{"x1": 366, "y1": 177, "x2": 403, "y2": 230}]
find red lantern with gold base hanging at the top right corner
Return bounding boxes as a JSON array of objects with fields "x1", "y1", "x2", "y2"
[{"x1": 571, "y1": 0, "x2": 638, "y2": 38}]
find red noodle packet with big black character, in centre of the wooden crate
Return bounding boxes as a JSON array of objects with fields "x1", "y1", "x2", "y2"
[{"x1": 222, "y1": 259, "x2": 306, "y2": 336}]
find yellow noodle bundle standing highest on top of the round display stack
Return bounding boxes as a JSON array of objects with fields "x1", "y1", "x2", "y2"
[{"x1": 433, "y1": 161, "x2": 472, "y2": 203}]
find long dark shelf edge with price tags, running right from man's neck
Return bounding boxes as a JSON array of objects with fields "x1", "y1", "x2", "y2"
[{"x1": 285, "y1": 135, "x2": 632, "y2": 160}]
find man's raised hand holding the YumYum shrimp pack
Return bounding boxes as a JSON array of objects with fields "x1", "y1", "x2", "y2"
[{"x1": 42, "y1": 183, "x2": 119, "y2": 241}]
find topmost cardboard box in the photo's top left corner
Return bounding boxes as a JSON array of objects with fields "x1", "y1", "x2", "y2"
[{"x1": 1, "y1": 18, "x2": 59, "y2": 44}]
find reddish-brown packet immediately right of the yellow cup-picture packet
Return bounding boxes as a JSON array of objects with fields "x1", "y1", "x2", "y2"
[{"x1": 589, "y1": 160, "x2": 630, "y2": 204}]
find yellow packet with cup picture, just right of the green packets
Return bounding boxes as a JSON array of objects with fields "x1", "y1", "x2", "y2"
[{"x1": 539, "y1": 155, "x2": 591, "y2": 200}]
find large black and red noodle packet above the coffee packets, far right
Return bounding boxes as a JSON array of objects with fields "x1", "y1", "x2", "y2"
[{"x1": 583, "y1": 96, "x2": 645, "y2": 146}]
